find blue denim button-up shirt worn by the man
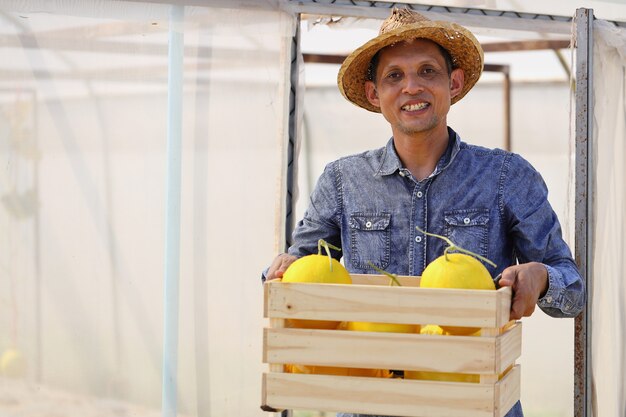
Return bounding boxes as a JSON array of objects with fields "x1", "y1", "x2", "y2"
[{"x1": 288, "y1": 128, "x2": 585, "y2": 317}]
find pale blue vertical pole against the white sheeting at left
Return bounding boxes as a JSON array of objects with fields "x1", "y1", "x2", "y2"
[{"x1": 162, "y1": 5, "x2": 185, "y2": 417}]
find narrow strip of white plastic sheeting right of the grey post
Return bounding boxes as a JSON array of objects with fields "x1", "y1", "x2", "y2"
[{"x1": 590, "y1": 21, "x2": 626, "y2": 417}]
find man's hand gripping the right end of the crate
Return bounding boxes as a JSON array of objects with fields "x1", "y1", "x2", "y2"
[{"x1": 500, "y1": 262, "x2": 548, "y2": 320}]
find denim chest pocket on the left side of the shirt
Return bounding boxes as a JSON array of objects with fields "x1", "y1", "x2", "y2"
[{"x1": 350, "y1": 213, "x2": 391, "y2": 270}]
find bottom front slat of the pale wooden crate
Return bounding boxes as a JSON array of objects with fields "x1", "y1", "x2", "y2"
[{"x1": 263, "y1": 369, "x2": 519, "y2": 417}]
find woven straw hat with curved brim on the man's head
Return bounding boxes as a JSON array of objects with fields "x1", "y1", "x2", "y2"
[{"x1": 337, "y1": 8, "x2": 483, "y2": 113}]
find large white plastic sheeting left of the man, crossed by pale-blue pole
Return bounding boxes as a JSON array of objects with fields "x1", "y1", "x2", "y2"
[{"x1": 0, "y1": 1, "x2": 295, "y2": 417}]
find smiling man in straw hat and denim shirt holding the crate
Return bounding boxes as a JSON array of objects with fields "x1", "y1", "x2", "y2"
[{"x1": 266, "y1": 10, "x2": 584, "y2": 416}]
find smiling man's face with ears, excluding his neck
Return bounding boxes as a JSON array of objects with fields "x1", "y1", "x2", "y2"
[{"x1": 365, "y1": 39, "x2": 464, "y2": 135}]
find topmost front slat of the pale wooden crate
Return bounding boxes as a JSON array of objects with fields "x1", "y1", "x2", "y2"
[{"x1": 265, "y1": 281, "x2": 511, "y2": 327}]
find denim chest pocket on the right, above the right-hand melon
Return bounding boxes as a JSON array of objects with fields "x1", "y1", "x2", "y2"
[{"x1": 444, "y1": 209, "x2": 489, "y2": 257}]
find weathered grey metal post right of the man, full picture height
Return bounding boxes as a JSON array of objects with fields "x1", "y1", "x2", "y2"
[{"x1": 574, "y1": 8, "x2": 594, "y2": 417}]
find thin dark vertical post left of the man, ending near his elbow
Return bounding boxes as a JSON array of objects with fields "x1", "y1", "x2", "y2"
[{"x1": 284, "y1": 14, "x2": 300, "y2": 251}]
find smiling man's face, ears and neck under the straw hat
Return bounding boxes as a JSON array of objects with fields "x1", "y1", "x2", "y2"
[{"x1": 365, "y1": 39, "x2": 464, "y2": 180}]
